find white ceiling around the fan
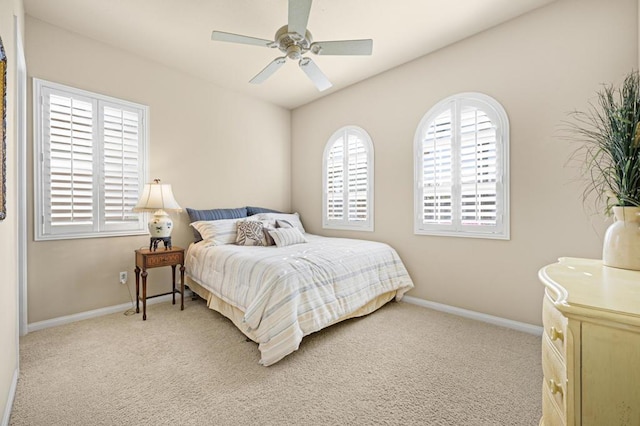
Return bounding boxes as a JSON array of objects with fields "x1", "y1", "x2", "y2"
[{"x1": 24, "y1": 0, "x2": 553, "y2": 108}]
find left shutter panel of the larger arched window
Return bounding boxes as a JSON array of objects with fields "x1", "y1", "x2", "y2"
[{"x1": 422, "y1": 109, "x2": 454, "y2": 225}]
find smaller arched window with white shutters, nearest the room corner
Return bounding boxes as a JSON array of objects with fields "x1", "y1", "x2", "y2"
[{"x1": 322, "y1": 126, "x2": 373, "y2": 231}]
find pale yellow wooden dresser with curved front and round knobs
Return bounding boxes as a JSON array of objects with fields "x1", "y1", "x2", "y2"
[{"x1": 538, "y1": 257, "x2": 640, "y2": 426}]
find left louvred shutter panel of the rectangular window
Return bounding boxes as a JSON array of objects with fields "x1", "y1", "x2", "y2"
[{"x1": 43, "y1": 93, "x2": 96, "y2": 233}]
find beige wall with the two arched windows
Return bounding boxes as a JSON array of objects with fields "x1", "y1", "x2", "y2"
[{"x1": 292, "y1": 0, "x2": 638, "y2": 324}]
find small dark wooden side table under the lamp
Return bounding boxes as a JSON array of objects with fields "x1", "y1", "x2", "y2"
[{"x1": 136, "y1": 247, "x2": 184, "y2": 321}]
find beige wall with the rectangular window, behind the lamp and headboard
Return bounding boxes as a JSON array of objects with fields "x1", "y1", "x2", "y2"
[{"x1": 26, "y1": 17, "x2": 291, "y2": 323}]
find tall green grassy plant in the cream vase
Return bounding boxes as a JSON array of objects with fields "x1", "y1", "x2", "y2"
[{"x1": 571, "y1": 71, "x2": 640, "y2": 213}]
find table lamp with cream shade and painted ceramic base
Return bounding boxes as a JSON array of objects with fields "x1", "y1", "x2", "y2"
[{"x1": 133, "y1": 179, "x2": 182, "y2": 251}]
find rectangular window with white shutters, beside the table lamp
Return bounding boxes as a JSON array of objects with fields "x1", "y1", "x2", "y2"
[{"x1": 33, "y1": 79, "x2": 148, "y2": 240}]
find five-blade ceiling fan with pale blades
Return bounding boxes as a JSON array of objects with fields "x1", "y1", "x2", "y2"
[{"x1": 211, "y1": 0, "x2": 373, "y2": 91}]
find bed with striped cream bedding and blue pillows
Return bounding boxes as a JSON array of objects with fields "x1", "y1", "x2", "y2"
[{"x1": 185, "y1": 208, "x2": 413, "y2": 366}]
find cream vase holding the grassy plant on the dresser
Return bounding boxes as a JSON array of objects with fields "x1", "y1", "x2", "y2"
[{"x1": 602, "y1": 207, "x2": 640, "y2": 271}]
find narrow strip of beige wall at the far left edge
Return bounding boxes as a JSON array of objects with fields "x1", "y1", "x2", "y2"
[{"x1": 0, "y1": 0, "x2": 23, "y2": 421}]
